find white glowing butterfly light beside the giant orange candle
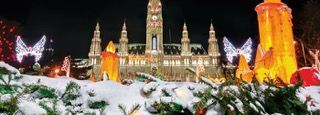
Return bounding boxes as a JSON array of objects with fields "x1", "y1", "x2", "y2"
[{"x1": 223, "y1": 37, "x2": 252, "y2": 63}]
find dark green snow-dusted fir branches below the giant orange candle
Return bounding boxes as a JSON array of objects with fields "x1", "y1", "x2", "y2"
[{"x1": 194, "y1": 77, "x2": 308, "y2": 114}]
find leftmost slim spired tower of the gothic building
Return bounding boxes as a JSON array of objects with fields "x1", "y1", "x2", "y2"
[{"x1": 88, "y1": 22, "x2": 101, "y2": 78}]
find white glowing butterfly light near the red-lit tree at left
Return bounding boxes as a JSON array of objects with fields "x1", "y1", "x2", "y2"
[{"x1": 16, "y1": 36, "x2": 46, "y2": 63}]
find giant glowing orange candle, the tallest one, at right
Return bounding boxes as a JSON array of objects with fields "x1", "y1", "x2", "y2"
[{"x1": 256, "y1": 0, "x2": 297, "y2": 83}]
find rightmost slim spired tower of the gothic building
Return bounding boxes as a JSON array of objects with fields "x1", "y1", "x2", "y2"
[{"x1": 208, "y1": 23, "x2": 220, "y2": 65}]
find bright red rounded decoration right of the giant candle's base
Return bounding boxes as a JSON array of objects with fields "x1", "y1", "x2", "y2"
[{"x1": 290, "y1": 67, "x2": 320, "y2": 86}]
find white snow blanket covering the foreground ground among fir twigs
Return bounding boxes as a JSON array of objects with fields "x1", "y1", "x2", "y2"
[{"x1": 0, "y1": 62, "x2": 320, "y2": 115}]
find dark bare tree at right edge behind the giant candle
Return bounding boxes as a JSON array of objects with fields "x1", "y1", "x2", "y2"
[{"x1": 293, "y1": 0, "x2": 320, "y2": 66}]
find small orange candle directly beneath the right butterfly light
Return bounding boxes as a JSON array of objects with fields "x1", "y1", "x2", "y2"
[{"x1": 236, "y1": 55, "x2": 254, "y2": 83}]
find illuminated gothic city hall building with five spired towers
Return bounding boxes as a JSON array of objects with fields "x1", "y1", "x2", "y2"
[{"x1": 89, "y1": 0, "x2": 220, "y2": 81}]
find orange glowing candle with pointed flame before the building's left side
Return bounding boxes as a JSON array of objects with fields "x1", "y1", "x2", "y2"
[{"x1": 99, "y1": 41, "x2": 120, "y2": 83}]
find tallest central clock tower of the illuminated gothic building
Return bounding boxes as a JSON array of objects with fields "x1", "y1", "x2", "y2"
[{"x1": 145, "y1": 0, "x2": 163, "y2": 54}]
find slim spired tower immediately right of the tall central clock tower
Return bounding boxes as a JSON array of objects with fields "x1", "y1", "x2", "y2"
[{"x1": 181, "y1": 22, "x2": 192, "y2": 56}]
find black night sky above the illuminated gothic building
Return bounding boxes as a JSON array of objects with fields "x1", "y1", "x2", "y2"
[{"x1": 0, "y1": 0, "x2": 305, "y2": 58}]
